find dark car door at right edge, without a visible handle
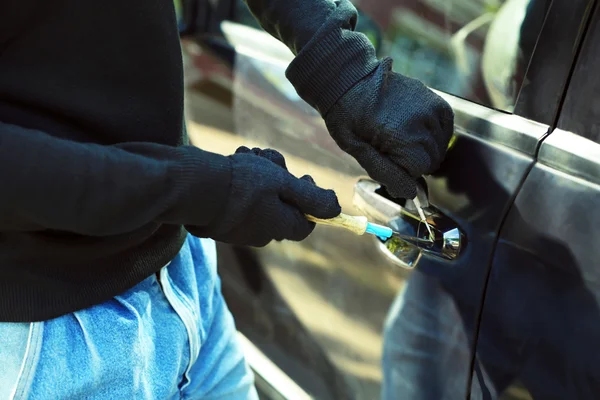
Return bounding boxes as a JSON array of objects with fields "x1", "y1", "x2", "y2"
[{"x1": 472, "y1": 4, "x2": 600, "y2": 399}]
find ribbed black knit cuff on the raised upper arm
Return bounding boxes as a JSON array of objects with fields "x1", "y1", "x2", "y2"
[{"x1": 286, "y1": 0, "x2": 379, "y2": 117}]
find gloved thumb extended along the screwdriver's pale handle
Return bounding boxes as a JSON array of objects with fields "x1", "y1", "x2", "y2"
[{"x1": 280, "y1": 175, "x2": 342, "y2": 219}]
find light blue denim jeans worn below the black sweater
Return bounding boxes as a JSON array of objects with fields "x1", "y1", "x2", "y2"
[{"x1": 0, "y1": 236, "x2": 258, "y2": 400}]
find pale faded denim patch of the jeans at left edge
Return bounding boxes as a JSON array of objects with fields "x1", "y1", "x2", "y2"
[{"x1": 0, "y1": 322, "x2": 44, "y2": 400}]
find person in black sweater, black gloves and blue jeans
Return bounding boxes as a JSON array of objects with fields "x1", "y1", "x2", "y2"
[{"x1": 0, "y1": 0, "x2": 453, "y2": 399}]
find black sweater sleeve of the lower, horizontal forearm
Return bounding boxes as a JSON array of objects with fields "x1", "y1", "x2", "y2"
[{"x1": 0, "y1": 123, "x2": 231, "y2": 236}]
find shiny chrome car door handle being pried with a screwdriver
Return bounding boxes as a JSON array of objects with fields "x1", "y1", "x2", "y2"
[{"x1": 354, "y1": 179, "x2": 465, "y2": 269}]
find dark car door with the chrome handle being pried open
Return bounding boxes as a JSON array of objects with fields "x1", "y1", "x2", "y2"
[{"x1": 178, "y1": 0, "x2": 586, "y2": 399}]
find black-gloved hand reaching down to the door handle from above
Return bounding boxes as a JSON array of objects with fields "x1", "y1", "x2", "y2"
[{"x1": 324, "y1": 59, "x2": 454, "y2": 199}]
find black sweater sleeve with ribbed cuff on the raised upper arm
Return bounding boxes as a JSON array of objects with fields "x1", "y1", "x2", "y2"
[{"x1": 245, "y1": 0, "x2": 380, "y2": 116}]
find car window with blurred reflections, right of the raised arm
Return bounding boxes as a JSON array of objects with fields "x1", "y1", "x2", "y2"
[{"x1": 355, "y1": 0, "x2": 550, "y2": 112}]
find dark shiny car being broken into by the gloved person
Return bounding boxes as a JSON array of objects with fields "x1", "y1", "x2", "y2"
[{"x1": 180, "y1": 0, "x2": 600, "y2": 400}]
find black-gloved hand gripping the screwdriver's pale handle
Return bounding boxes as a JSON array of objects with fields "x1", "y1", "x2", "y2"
[{"x1": 186, "y1": 147, "x2": 341, "y2": 247}]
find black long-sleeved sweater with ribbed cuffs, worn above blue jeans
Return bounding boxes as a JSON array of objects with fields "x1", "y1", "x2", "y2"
[{"x1": 0, "y1": 0, "x2": 375, "y2": 321}]
